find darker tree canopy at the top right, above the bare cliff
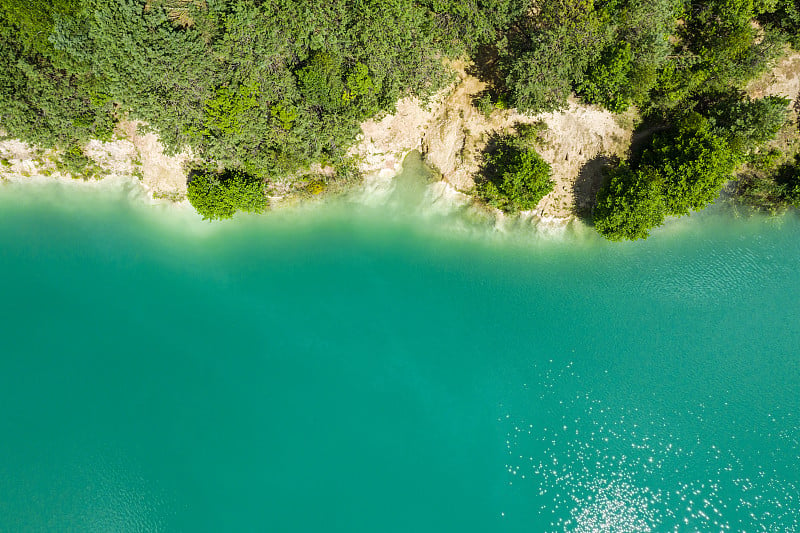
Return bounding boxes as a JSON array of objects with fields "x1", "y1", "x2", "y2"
[{"x1": 468, "y1": 0, "x2": 788, "y2": 114}]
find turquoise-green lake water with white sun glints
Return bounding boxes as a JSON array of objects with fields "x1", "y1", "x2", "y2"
[{"x1": 0, "y1": 164, "x2": 800, "y2": 532}]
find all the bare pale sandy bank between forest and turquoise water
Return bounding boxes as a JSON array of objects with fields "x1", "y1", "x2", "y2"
[{"x1": 0, "y1": 48, "x2": 800, "y2": 231}]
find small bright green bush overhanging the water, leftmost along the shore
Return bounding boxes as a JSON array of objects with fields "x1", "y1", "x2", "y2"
[{"x1": 186, "y1": 172, "x2": 267, "y2": 220}]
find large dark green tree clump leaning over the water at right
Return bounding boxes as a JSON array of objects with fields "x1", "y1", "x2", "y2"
[{"x1": 594, "y1": 90, "x2": 790, "y2": 240}]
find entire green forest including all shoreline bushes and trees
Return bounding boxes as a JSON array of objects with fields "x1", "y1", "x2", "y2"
[{"x1": 0, "y1": 0, "x2": 800, "y2": 240}]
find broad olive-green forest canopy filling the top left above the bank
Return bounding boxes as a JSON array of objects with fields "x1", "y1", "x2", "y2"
[{"x1": 0, "y1": 0, "x2": 511, "y2": 178}]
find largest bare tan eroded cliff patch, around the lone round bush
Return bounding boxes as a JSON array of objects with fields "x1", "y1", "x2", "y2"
[{"x1": 352, "y1": 63, "x2": 632, "y2": 219}]
